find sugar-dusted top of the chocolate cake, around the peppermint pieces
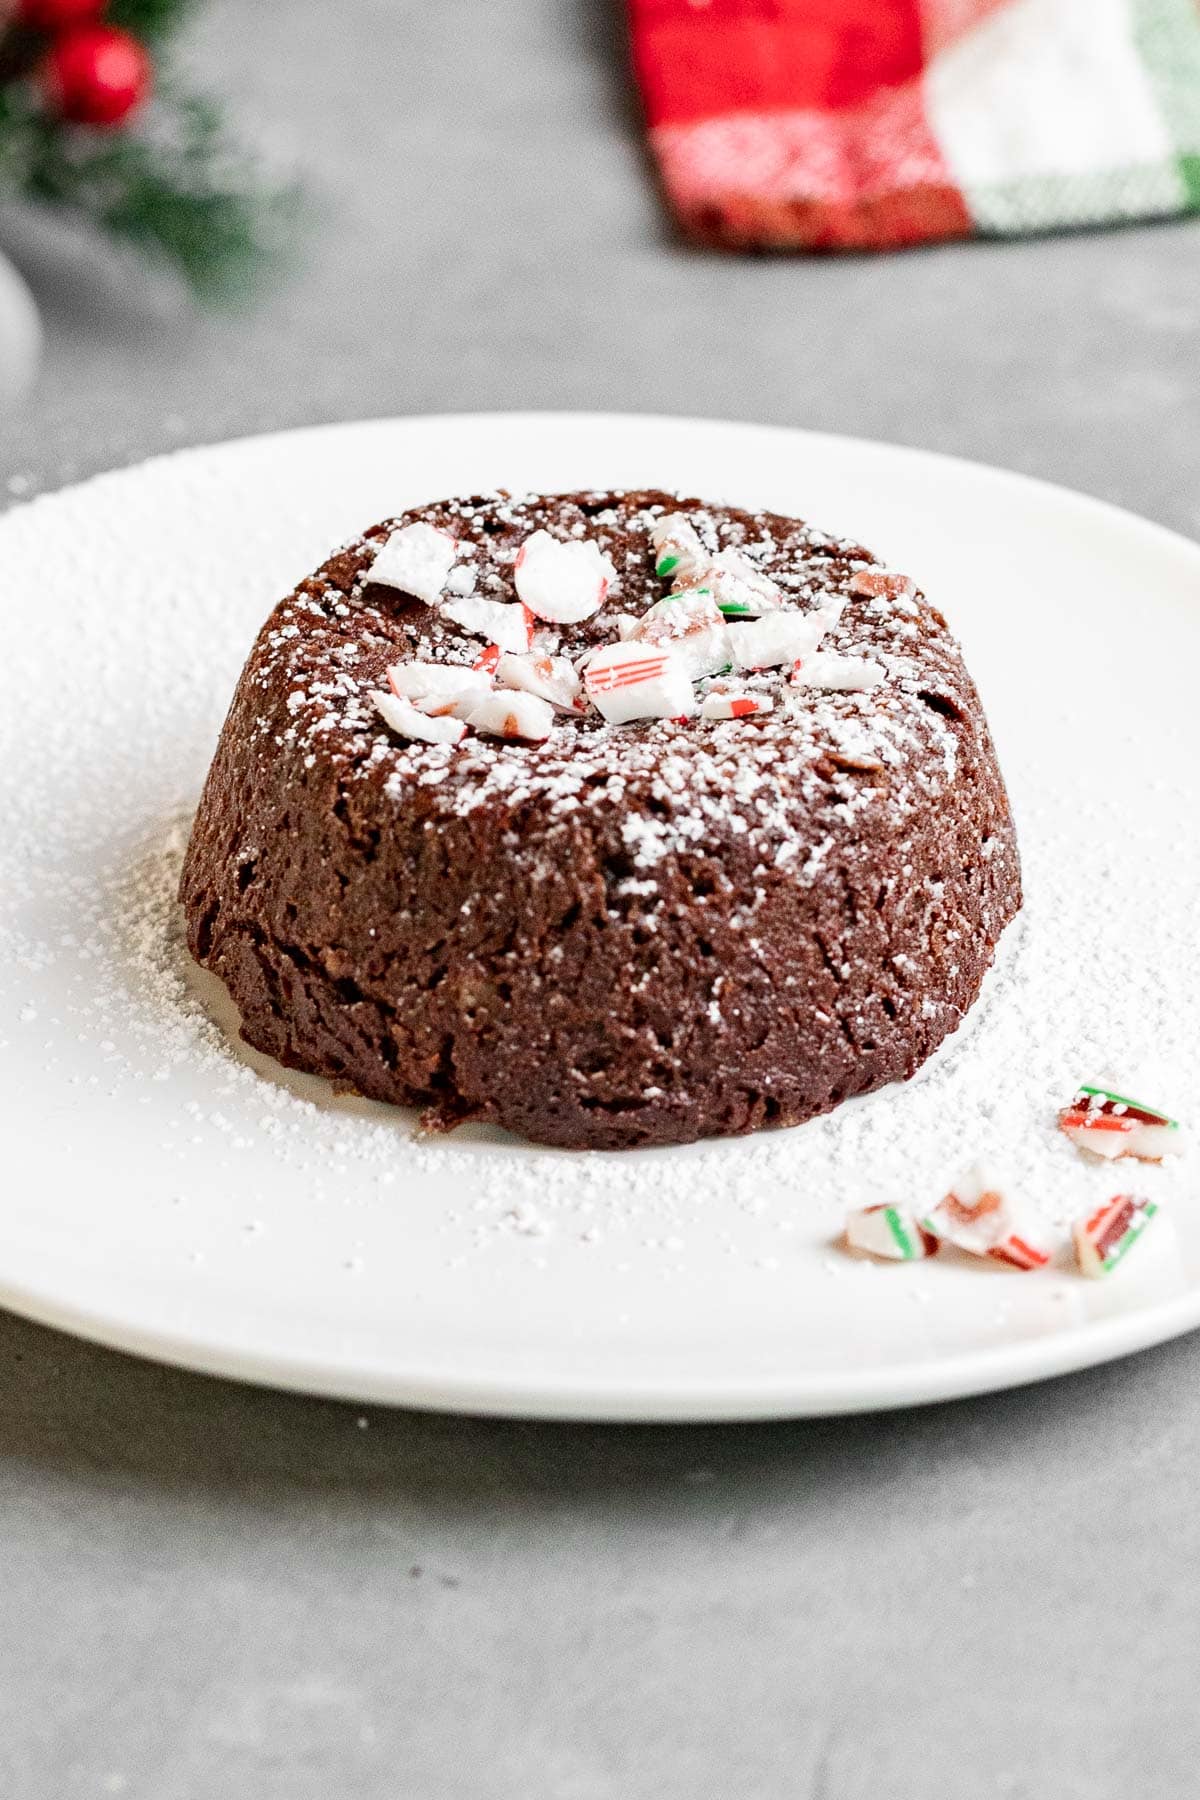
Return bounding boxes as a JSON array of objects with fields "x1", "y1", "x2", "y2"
[{"x1": 257, "y1": 491, "x2": 986, "y2": 880}]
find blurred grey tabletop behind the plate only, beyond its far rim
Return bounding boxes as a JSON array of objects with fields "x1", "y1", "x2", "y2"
[{"x1": 0, "y1": 0, "x2": 1200, "y2": 533}]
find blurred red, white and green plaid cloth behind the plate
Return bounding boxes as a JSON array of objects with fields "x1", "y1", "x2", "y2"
[{"x1": 630, "y1": 0, "x2": 1200, "y2": 250}]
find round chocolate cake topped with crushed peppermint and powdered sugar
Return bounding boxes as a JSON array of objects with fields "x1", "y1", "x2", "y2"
[{"x1": 180, "y1": 491, "x2": 1020, "y2": 1148}]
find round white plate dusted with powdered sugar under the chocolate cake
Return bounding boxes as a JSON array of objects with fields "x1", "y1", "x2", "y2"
[{"x1": 0, "y1": 416, "x2": 1200, "y2": 1418}]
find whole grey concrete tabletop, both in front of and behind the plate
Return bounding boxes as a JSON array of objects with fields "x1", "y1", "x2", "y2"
[{"x1": 0, "y1": 0, "x2": 1200, "y2": 1800}]
